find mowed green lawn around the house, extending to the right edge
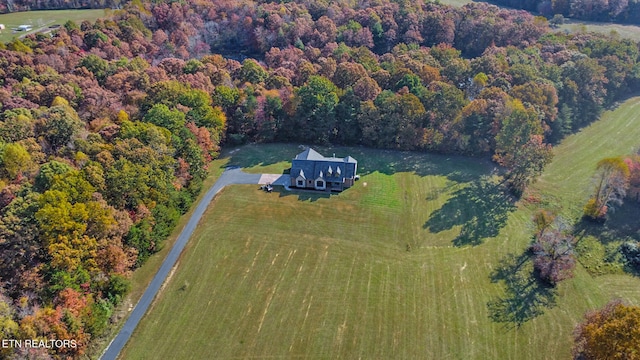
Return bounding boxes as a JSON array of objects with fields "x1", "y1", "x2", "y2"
[{"x1": 122, "y1": 98, "x2": 640, "y2": 359}]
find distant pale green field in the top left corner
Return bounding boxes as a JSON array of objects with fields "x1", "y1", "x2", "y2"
[{"x1": 0, "y1": 9, "x2": 109, "y2": 43}]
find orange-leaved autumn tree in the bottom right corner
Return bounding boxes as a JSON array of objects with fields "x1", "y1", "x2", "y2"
[{"x1": 572, "y1": 300, "x2": 640, "y2": 360}]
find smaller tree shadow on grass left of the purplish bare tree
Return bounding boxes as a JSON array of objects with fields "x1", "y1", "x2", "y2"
[{"x1": 487, "y1": 252, "x2": 558, "y2": 329}]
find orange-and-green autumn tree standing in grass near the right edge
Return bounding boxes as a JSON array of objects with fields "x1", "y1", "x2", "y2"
[{"x1": 584, "y1": 157, "x2": 630, "y2": 221}]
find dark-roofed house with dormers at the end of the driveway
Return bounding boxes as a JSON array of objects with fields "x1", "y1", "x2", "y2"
[{"x1": 290, "y1": 148, "x2": 358, "y2": 191}]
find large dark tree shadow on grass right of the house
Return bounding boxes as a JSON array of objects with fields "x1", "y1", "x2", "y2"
[{"x1": 423, "y1": 176, "x2": 516, "y2": 246}]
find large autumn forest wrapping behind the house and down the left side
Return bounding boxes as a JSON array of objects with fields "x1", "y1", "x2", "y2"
[{"x1": 0, "y1": 0, "x2": 640, "y2": 357}]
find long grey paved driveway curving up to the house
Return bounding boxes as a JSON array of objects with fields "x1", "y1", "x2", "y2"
[{"x1": 100, "y1": 168, "x2": 276, "y2": 360}]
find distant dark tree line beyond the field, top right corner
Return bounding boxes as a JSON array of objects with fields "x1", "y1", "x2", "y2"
[{"x1": 482, "y1": 0, "x2": 640, "y2": 24}]
